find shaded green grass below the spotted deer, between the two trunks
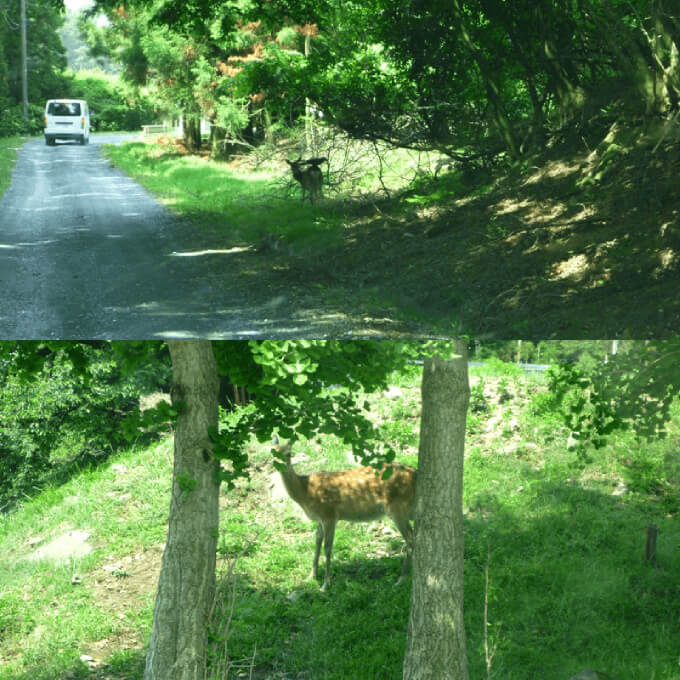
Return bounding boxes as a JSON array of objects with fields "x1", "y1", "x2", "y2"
[{"x1": 219, "y1": 556, "x2": 410, "y2": 680}]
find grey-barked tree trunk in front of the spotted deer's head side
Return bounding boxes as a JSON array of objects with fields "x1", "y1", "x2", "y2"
[{"x1": 144, "y1": 340, "x2": 219, "y2": 680}]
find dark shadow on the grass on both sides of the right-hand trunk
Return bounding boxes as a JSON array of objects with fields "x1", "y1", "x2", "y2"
[{"x1": 219, "y1": 474, "x2": 680, "y2": 680}]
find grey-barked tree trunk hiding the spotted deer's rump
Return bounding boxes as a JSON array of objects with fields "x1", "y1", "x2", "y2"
[{"x1": 403, "y1": 341, "x2": 470, "y2": 680}]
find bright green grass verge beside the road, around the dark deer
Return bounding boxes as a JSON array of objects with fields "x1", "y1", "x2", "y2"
[{"x1": 103, "y1": 140, "x2": 446, "y2": 253}]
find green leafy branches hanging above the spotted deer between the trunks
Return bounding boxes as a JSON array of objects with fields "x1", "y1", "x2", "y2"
[{"x1": 214, "y1": 340, "x2": 422, "y2": 485}]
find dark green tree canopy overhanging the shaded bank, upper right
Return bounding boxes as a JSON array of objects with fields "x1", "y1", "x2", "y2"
[{"x1": 240, "y1": 0, "x2": 680, "y2": 159}]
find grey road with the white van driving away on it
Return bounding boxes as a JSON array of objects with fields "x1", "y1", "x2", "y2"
[{"x1": 0, "y1": 135, "x2": 350, "y2": 339}]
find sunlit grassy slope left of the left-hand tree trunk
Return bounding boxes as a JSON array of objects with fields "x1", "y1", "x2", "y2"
[{"x1": 0, "y1": 445, "x2": 171, "y2": 680}]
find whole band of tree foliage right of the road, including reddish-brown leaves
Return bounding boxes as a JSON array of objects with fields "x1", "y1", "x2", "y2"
[{"x1": 85, "y1": 0, "x2": 680, "y2": 160}]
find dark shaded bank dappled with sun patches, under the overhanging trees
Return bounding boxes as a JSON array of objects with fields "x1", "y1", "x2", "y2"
[{"x1": 260, "y1": 139, "x2": 680, "y2": 338}]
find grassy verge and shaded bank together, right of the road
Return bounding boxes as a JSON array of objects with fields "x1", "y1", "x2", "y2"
[{"x1": 102, "y1": 119, "x2": 680, "y2": 338}]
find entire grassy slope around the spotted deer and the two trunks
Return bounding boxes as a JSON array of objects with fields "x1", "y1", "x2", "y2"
[{"x1": 0, "y1": 367, "x2": 680, "y2": 680}]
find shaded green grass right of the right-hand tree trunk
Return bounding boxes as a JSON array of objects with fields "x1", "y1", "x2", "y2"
[{"x1": 465, "y1": 478, "x2": 680, "y2": 680}]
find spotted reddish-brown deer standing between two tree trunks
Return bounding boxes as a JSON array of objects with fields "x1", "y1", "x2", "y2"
[{"x1": 274, "y1": 439, "x2": 417, "y2": 591}]
